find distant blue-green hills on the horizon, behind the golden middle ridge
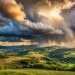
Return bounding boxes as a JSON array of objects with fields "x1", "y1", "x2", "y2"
[{"x1": 0, "y1": 46, "x2": 75, "y2": 64}]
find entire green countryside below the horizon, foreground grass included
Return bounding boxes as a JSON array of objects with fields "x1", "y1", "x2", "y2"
[{"x1": 0, "y1": 47, "x2": 75, "y2": 75}]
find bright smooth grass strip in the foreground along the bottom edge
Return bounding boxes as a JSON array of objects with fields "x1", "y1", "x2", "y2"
[{"x1": 0, "y1": 69, "x2": 75, "y2": 75}]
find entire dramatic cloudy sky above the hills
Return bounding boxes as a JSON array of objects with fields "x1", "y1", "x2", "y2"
[{"x1": 0, "y1": 0, "x2": 75, "y2": 47}]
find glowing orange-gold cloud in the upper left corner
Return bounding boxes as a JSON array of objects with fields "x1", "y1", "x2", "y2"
[{"x1": 0, "y1": 0, "x2": 26, "y2": 21}]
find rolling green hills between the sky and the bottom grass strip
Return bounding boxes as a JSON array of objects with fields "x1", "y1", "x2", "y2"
[{"x1": 0, "y1": 46, "x2": 75, "y2": 71}]
